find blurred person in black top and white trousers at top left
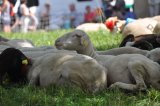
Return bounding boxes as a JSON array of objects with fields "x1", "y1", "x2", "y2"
[{"x1": 27, "y1": 0, "x2": 39, "y2": 30}]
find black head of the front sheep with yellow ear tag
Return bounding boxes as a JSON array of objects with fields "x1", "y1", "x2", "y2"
[{"x1": 0, "y1": 48, "x2": 30, "y2": 84}]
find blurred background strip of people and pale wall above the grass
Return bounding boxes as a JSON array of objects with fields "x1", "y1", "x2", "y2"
[{"x1": 0, "y1": 0, "x2": 160, "y2": 32}]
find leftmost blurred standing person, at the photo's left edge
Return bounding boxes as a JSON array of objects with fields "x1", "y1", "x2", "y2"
[{"x1": 0, "y1": 0, "x2": 11, "y2": 32}]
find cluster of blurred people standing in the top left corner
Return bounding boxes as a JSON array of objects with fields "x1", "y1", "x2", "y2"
[{"x1": 0, "y1": 0, "x2": 39, "y2": 32}]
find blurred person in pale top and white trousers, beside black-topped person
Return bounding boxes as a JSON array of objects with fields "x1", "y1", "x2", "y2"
[{"x1": 20, "y1": 0, "x2": 30, "y2": 33}]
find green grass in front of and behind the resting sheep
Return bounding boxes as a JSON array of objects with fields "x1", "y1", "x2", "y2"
[{"x1": 0, "y1": 30, "x2": 160, "y2": 106}]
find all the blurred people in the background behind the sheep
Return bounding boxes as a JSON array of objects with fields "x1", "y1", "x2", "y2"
[{"x1": 0, "y1": 0, "x2": 160, "y2": 32}]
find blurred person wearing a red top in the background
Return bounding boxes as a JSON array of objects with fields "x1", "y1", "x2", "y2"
[{"x1": 84, "y1": 6, "x2": 96, "y2": 22}]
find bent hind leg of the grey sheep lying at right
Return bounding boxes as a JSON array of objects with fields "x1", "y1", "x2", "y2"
[{"x1": 110, "y1": 62, "x2": 147, "y2": 91}]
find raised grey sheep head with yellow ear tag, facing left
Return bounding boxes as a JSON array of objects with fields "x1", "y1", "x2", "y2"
[{"x1": 55, "y1": 30, "x2": 91, "y2": 51}]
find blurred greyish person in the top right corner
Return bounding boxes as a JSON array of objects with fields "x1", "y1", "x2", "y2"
[{"x1": 148, "y1": 0, "x2": 160, "y2": 17}]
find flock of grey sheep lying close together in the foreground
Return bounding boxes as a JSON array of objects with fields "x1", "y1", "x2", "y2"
[{"x1": 0, "y1": 30, "x2": 160, "y2": 93}]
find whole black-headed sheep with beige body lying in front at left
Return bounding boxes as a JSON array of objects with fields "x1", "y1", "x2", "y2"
[{"x1": 0, "y1": 48, "x2": 107, "y2": 93}]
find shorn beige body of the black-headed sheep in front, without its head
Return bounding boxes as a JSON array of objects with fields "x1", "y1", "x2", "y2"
[{"x1": 28, "y1": 53, "x2": 107, "y2": 93}]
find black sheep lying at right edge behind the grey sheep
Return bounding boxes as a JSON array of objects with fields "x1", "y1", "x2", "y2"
[{"x1": 119, "y1": 34, "x2": 160, "y2": 50}]
